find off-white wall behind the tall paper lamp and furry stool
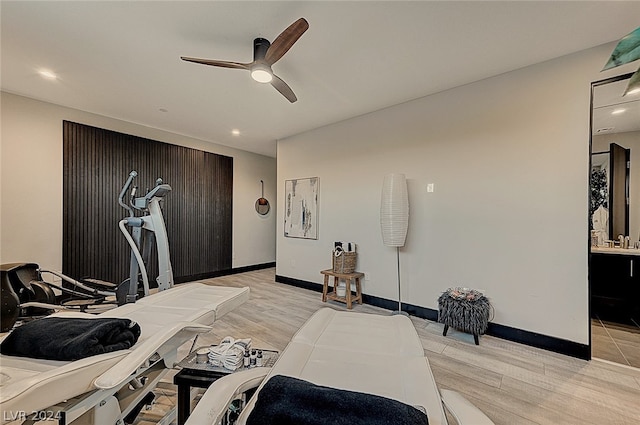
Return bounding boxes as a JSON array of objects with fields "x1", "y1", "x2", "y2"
[{"x1": 277, "y1": 45, "x2": 629, "y2": 344}]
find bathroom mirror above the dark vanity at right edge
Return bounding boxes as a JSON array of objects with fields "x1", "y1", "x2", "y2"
[{"x1": 590, "y1": 75, "x2": 640, "y2": 241}]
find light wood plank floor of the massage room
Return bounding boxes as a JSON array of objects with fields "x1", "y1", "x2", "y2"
[{"x1": 145, "y1": 269, "x2": 640, "y2": 425}]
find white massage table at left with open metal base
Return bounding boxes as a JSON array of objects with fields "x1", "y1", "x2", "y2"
[{"x1": 0, "y1": 283, "x2": 249, "y2": 425}]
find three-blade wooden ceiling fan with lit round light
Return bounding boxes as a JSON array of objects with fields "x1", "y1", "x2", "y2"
[{"x1": 181, "y1": 18, "x2": 309, "y2": 103}]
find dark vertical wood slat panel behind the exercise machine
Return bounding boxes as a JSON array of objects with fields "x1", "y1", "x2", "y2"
[{"x1": 62, "y1": 121, "x2": 233, "y2": 286}]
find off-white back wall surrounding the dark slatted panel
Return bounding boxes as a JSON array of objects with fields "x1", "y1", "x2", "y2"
[{"x1": 0, "y1": 92, "x2": 276, "y2": 270}]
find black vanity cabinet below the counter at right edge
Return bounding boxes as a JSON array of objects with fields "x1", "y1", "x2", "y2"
[{"x1": 589, "y1": 252, "x2": 640, "y2": 323}]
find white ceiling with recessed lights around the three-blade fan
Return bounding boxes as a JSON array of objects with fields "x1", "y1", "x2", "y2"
[{"x1": 0, "y1": 0, "x2": 640, "y2": 156}]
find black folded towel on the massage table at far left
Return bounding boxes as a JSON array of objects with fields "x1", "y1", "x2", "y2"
[{"x1": 0, "y1": 317, "x2": 140, "y2": 360}]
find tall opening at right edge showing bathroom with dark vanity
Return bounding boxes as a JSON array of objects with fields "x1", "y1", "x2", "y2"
[{"x1": 589, "y1": 74, "x2": 640, "y2": 368}]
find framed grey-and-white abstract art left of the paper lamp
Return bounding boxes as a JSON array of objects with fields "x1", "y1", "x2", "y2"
[{"x1": 284, "y1": 177, "x2": 319, "y2": 239}]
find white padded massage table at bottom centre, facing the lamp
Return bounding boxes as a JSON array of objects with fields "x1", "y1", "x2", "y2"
[{"x1": 186, "y1": 308, "x2": 493, "y2": 425}]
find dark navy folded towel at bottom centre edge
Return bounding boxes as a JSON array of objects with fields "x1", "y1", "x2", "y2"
[{"x1": 247, "y1": 375, "x2": 429, "y2": 425}]
